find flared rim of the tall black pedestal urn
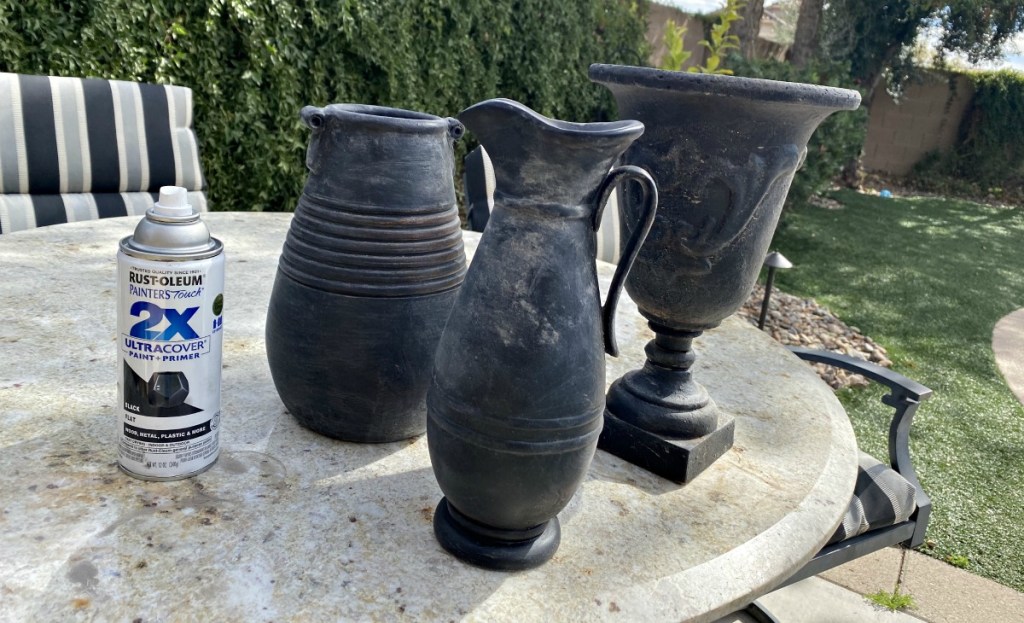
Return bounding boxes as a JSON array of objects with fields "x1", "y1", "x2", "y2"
[{"x1": 589, "y1": 64, "x2": 860, "y2": 111}]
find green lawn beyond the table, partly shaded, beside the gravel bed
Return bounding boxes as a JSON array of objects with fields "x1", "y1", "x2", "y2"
[{"x1": 772, "y1": 191, "x2": 1024, "y2": 591}]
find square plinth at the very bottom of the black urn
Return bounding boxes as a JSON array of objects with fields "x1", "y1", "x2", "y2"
[{"x1": 597, "y1": 410, "x2": 736, "y2": 485}]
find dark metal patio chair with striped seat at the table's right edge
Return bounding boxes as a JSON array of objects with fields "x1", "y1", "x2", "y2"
[{"x1": 744, "y1": 346, "x2": 932, "y2": 622}]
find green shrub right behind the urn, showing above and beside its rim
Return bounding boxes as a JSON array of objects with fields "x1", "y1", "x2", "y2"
[{"x1": 729, "y1": 54, "x2": 867, "y2": 206}]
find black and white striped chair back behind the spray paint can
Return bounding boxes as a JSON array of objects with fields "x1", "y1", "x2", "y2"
[{"x1": 0, "y1": 73, "x2": 206, "y2": 234}]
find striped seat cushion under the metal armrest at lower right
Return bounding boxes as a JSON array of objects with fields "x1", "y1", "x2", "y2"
[{"x1": 828, "y1": 452, "x2": 918, "y2": 544}]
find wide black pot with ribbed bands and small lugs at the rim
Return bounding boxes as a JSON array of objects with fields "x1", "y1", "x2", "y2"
[{"x1": 266, "y1": 105, "x2": 466, "y2": 442}]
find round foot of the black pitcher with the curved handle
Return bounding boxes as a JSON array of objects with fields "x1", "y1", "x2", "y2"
[{"x1": 434, "y1": 498, "x2": 561, "y2": 571}]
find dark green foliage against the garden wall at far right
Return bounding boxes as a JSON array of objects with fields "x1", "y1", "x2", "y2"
[{"x1": 909, "y1": 70, "x2": 1024, "y2": 203}]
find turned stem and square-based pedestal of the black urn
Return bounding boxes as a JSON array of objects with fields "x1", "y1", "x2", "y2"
[{"x1": 597, "y1": 322, "x2": 734, "y2": 484}]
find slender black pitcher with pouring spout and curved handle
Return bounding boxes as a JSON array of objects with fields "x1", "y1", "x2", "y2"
[{"x1": 427, "y1": 99, "x2": 657, "y2": 569}]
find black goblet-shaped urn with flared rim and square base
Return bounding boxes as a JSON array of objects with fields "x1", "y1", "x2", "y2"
[{"x1": 590, "y1": 65, "x2": 860, "y2": 482}]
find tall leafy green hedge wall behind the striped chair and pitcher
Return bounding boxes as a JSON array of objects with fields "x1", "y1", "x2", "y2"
[{"x1": 0, "y1": 0, "x2": 646, "y2": 211}]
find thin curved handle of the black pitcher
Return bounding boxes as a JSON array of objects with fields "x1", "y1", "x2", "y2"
[{"x1": 594, "y1": 165, "x2": 657, "y2": 357}]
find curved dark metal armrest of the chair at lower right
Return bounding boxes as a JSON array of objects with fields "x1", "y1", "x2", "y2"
[{"x1": 787, "y1": 346, "x2": 932, "y2": 547}]
